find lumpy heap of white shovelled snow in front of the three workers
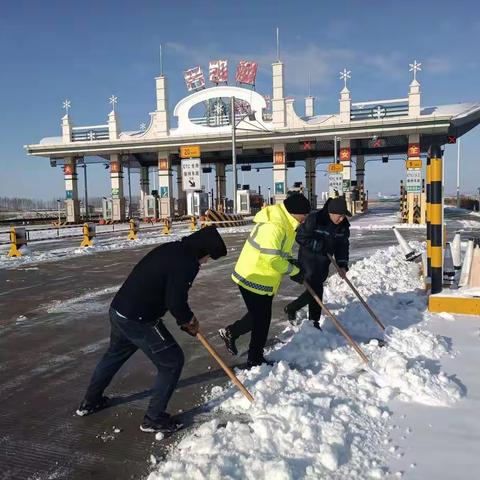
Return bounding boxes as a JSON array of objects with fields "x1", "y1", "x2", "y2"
[{"x1": 149, "y1": 247, "x2": 461, "y2": 480}]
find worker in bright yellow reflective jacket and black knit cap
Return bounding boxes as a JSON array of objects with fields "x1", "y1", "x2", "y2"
[{"x1": 218, "y1": 193, "x2": 310, "y2": 368}]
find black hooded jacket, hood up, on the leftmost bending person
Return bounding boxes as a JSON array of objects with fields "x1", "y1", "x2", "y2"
[{"x1": 111, "y1": 227, "x2": 227, "y2": 325}]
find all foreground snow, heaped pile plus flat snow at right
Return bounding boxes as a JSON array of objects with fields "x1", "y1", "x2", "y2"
[{"x1": 149, "y1": 244, "x2": 480, "y2": 480}]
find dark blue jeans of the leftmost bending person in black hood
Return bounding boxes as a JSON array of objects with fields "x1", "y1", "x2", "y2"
[{"x1": 85, "y1": 308, "x2": 184, "y2": 421}]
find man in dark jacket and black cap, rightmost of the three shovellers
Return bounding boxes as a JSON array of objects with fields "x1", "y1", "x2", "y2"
[{"x1": 285, "y1": 197, "x2": 352, "y2": 328}]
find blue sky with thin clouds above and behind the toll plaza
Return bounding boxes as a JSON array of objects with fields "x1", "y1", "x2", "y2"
[{"x1": 0, "y1": 0, "x2": 480, "y2": 199}]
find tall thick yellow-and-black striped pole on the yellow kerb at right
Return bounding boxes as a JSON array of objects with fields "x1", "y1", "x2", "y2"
[{"x1": 427, "y1": 145, "x2": 443, "y2": 293}]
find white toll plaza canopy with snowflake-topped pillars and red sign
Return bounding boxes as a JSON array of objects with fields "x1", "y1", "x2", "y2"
[{"x1": 25, "y1": 61, "x2": 480, "y2": 226}]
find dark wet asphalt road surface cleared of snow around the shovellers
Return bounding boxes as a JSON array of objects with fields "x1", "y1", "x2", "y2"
[{"x1": 0, "y1": 205, "x2": 471, "y2": 480}]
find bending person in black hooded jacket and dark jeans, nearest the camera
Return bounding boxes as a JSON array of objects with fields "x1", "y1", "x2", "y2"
[{"x1": 77, "y1": 227, "x2": 227, "y2": 433}]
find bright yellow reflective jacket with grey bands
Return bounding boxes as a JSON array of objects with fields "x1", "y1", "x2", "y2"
[{"x1": 232, "y1": 203, "x2": 300, "y2": 295}]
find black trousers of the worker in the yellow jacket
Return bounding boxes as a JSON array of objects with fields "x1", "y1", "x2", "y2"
[{"x1": 228, "y1": 287, "x2": 273, "y2": 363}]
